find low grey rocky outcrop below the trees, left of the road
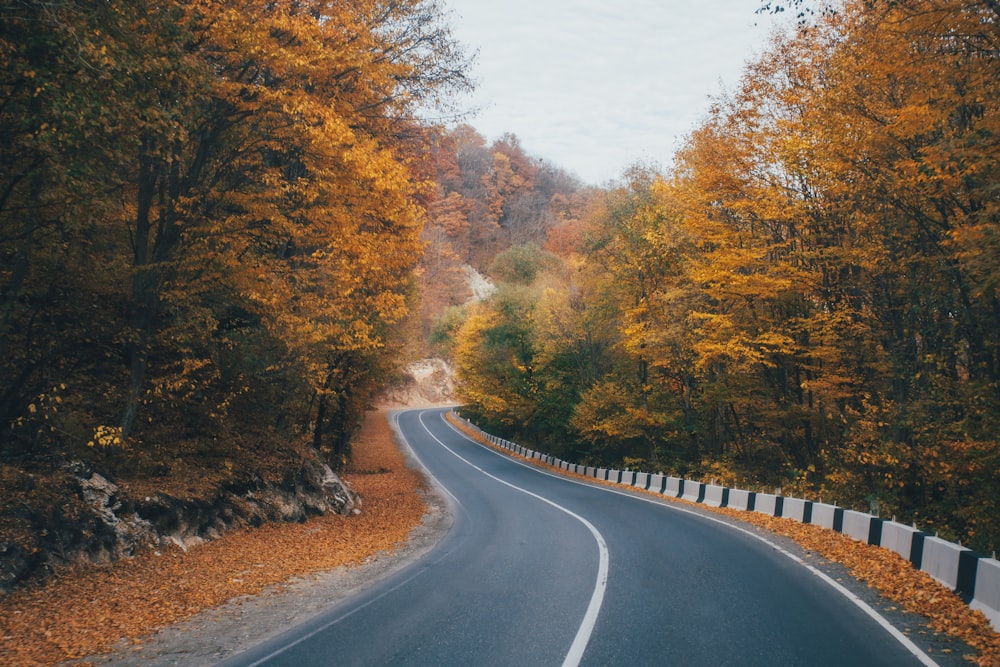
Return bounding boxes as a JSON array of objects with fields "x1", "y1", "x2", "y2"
[{"x1": 0, "y1": 459, "x2": 360, "y2": 591}]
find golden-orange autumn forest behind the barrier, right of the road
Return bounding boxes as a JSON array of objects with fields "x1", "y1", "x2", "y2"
[{"x1": 453, "y1": 0, "x2": 1000, "y2": 553}]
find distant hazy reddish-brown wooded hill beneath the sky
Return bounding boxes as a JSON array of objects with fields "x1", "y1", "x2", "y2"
[{"x1": 415, "y1": 125, "x2": 598, "y2": 350}]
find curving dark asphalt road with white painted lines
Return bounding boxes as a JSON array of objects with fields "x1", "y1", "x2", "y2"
[{"x1": 224, "y1": 410, "x2": 934, "y2": 667}]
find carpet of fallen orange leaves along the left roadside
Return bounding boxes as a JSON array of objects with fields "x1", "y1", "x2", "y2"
[{"x1": 0, "y1": 413, "x2": 426, "y2": 667}]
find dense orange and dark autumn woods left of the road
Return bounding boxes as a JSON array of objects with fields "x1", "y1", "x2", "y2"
[{"x1": 0, "y1": 0, "x2": 468, "y2": 585}]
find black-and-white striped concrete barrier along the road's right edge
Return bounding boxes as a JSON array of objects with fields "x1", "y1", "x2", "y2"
[{"x1": 459, "y1": 417, "x2": 1000, "y2": 632}]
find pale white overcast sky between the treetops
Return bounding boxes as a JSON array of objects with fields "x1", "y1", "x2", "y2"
[{"x1": 442, "y1": 0, "x2": 788, "y2": 185}]
